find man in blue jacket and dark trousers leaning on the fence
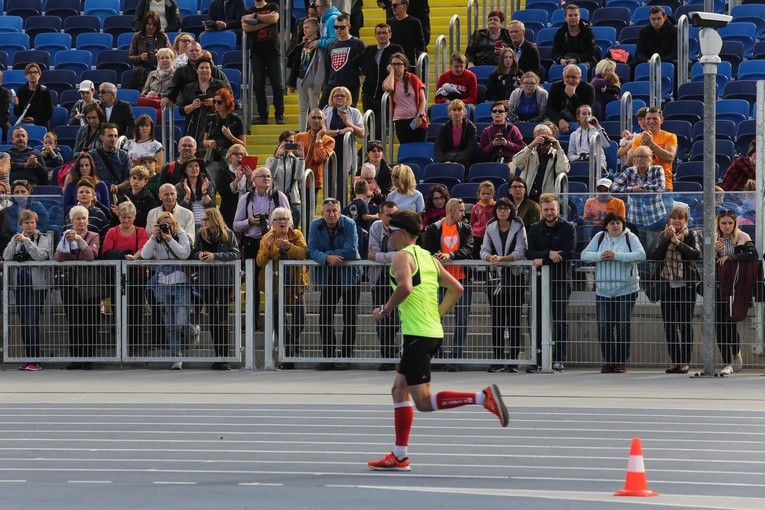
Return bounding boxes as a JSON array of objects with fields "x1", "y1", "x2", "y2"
[{"x1": 308, "y1": 198, "x2": 361, "y2": 370}]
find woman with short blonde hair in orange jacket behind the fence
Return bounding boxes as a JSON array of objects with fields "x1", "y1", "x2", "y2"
[{"x1": 255, "y1": 207, "x2": 308, "y2": 370}]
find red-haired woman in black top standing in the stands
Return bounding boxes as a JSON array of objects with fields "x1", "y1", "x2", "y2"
[{"x1": 202, "y1": 87, "x2": 247, "y2": 188}]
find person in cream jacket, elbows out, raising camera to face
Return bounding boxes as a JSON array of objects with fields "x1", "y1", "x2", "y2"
[{"x1": 513, "y1": 124, "x2": 570, "y2": 203}]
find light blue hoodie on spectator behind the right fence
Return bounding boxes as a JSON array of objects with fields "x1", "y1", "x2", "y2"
[{"x1": 581, "y1": 228, "x2": 645, "y2": 298}]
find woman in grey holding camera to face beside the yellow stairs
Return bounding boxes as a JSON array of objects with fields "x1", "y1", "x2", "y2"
[{"x1": 266, "y1": 131, "x2": 304, "y2": 228}]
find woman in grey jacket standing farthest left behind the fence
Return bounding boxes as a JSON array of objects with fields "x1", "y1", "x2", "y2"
[{"x1": 3, "y1": 210, "x2": 51, "y2": 371}]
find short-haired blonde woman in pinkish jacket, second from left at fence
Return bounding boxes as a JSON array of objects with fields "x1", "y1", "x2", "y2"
[{"x1": 53, "y1": 205, "x2": 106, "y2": 370}]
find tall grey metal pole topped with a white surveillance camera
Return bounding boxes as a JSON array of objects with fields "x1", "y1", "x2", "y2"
[{"x1": 690, "y1": 12, "x2": 733, "y2": 377}]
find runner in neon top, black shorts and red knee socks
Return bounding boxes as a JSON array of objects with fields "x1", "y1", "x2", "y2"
[{"x1": 368, "y1": 210, "x2": 508, "y2": 471}]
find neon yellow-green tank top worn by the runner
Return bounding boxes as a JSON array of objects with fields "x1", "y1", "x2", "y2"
[{"x1": 389, "y1": 244, "x2": 444, "y2": 338}]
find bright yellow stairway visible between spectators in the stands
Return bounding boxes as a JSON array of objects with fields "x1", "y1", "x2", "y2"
[{"x1": 247, "y1": 0, "x2": 468, "y2": 169}]
